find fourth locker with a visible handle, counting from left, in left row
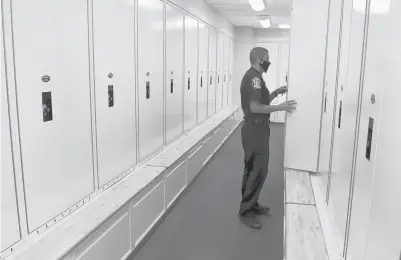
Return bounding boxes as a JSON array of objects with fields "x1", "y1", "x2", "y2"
[{"x1": 165, "y1": 5, "x2": 184, "y2": 143}]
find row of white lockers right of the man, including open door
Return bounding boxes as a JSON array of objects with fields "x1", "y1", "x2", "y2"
[{"x1": 285, "y1": 0, "x2": 401, "y2": 260}]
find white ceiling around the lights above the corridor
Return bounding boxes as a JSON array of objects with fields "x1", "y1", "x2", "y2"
[{"x1": 205, "y1": 0, "x2": 292, "y2": 28}]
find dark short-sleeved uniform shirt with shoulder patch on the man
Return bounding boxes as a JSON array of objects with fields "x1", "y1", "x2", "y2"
[{"x1": 241, "y1": 67, "x2": 270, "y2": 121}]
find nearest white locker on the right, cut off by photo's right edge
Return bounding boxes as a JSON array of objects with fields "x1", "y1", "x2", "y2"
[{"x1": 343, "y1": 0, "x2": 394, "y2": 259}]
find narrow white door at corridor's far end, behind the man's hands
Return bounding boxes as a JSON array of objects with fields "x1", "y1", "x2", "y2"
[{"x1": 276, "y1": 43, "x2": 289, "y2": 123}]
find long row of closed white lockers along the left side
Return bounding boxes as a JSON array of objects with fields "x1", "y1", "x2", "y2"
[{"x1": 1, "y1": 0, "x2": 233, "y2": 254}]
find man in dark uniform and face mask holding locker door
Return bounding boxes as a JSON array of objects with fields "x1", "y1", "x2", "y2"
[{"x1": 239, "y1": 47, "x2": 296, "y2": 229}]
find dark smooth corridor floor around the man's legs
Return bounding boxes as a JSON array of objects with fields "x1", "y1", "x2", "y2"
[{"x1": 128, "y1": 123, "x2": 284, "y2": 260}]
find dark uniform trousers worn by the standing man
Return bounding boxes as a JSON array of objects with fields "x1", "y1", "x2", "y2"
[{"x1": 239, "y1": 120, "x2": 270, "y2": 215}]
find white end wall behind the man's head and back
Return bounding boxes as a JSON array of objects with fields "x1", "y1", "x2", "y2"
[{"x1": 232, "y1": 27, "x2": 290, "y2": 105}]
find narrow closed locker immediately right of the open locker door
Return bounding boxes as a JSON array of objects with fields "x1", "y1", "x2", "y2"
[{"x1": 318, "y1": 0, "x2": 346, "y2": 193}]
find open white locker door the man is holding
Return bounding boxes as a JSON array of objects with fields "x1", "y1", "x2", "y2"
[{"x1": 284, "y1": 0, "x2": 329, "y2": 172}]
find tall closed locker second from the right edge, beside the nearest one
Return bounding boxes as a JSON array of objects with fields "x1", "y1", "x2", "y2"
[{"x1": 328, "y1": 1, "x2": 365, "y2": 254}]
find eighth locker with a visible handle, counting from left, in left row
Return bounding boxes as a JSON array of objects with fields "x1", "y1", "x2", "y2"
[{"x1": 216, "y1": 33, "x2": 224, "y2": 112}]
